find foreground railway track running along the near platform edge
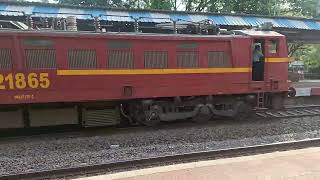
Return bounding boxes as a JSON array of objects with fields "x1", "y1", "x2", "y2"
[{"x1": 0, "y1": 139, "x2": 320, "y2": 179}]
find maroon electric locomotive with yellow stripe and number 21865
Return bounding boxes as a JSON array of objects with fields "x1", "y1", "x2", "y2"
[{"x1": 0, "y1": 30, "x2": 289, "y2": 128}]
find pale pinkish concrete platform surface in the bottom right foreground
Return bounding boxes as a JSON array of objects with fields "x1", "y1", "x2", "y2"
[{"x1": 75, "y1": 148, "x2": 320, "y2": 180}]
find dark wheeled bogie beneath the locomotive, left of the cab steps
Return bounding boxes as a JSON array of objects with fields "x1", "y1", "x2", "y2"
[{"x1": 125, "y1": 96, "x2": 258, "y2": 126}]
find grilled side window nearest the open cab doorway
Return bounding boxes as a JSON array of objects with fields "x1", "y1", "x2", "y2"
[{"x1": 208, "y1": 51, "x2": 232, "y2": 68}]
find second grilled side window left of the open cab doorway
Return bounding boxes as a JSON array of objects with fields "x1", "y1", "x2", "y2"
[{"x1": 177, "y1": 51, "x2": 199, "y2": 68}]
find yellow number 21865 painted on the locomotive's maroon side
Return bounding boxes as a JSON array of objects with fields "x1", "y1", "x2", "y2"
[{"x1": 0, "y1": 73, "x2": 50, "y2": 90}]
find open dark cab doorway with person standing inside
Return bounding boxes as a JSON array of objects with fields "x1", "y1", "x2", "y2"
[{"x1": 252, "y1": 39, "x2": 265, "y2": 81}]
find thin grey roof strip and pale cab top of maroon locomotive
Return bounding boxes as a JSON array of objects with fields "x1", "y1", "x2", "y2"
[{"x1": 0, "y1": 30, "x2": 284, "y2": 40}]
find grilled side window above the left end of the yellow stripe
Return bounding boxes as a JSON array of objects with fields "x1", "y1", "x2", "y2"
[{"x1": 68, "y1": 49, "x2": 97, "y2": 69}]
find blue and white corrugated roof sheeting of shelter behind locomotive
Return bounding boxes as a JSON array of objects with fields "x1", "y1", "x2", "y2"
[{"x1": 0, "y1": 2, "x2": 320, "y2": 30}]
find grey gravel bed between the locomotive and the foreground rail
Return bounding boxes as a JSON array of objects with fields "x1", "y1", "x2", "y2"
[{"x1": 0, "y1": 117, "x2": 320, "y2": 175}]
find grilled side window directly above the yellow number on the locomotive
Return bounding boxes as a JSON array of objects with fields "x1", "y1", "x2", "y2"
[{"x1": 25, "y1": 49, "x2": 57, "y2": 69}]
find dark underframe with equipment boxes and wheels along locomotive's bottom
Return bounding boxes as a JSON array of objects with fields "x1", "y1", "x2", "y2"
[{"x1": 0, "y1": 92, "x2": 286, "y2": 129}]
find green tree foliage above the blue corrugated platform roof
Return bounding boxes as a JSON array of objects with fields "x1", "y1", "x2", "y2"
[{"x1": 59, "y1": 0, "x2": 318, "y2": 17}]
